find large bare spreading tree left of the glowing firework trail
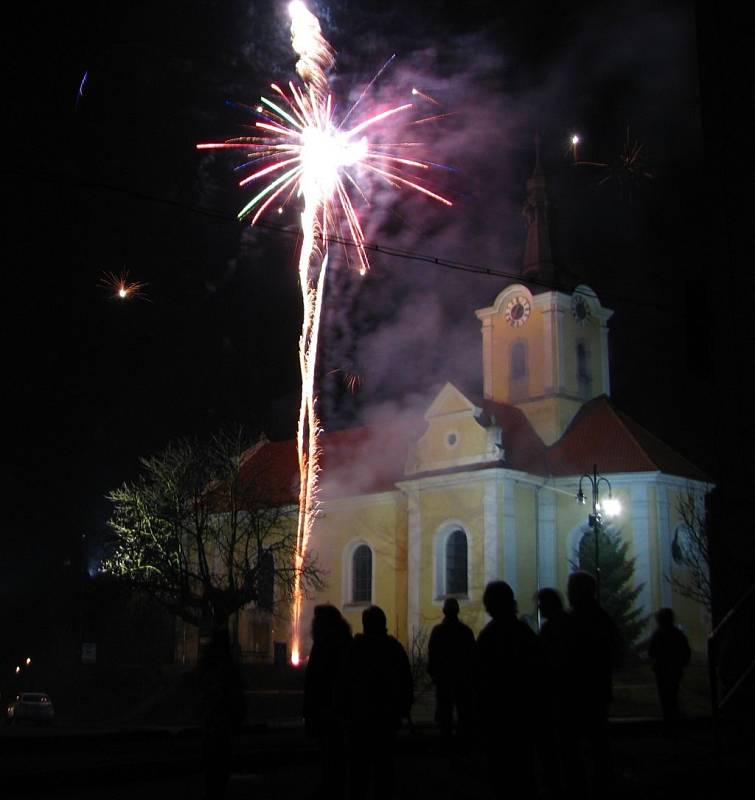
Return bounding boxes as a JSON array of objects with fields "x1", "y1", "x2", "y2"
[{"x1": 103, "y1": 429, "x2": 323, "y2": 628}]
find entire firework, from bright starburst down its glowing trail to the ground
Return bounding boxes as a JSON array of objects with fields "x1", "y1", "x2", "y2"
[{"x1": 197, "y1": 0, "x2": 452, "y2": 665}]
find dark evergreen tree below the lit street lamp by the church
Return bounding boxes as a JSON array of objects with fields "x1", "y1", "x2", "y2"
[{"x1": 572, "y1": 522, "x2": 647, "y2": 654}]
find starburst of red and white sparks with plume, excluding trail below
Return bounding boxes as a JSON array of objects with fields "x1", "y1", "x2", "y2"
[{"x1": 197, "y1": 18, "x2": 452, "y2": 274}]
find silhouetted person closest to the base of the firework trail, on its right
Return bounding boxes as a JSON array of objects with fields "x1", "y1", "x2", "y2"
[{"x1": 304, "y1": 604, "x2": 352, "y2": 800}]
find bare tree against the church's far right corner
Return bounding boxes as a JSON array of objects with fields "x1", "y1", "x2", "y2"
[{"x1": 667, "y1": 487, "x2": 712, "y2": 613}]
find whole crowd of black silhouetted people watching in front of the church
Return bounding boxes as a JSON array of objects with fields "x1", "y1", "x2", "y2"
[{"x1": 199, "y1": 572, "x2": 690, "y2": 800}]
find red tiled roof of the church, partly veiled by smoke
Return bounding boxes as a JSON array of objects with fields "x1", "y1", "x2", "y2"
[{"x1": 245, "y1": 395, "x2": 709, "y2": 503}]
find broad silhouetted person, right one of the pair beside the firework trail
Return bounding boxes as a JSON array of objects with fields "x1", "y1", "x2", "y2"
[{"x1": 346, "y1": 606, "x2": 413, "y2": 800}]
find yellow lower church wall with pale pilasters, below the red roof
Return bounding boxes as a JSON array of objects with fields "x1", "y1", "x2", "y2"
[{"x1": 303, "y1": 469, "x2": 709, "y2": 652}]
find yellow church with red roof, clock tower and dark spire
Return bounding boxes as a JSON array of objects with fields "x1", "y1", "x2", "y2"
[{"x1": 210, "y1": 148, "x2": 712, "y2": 658}]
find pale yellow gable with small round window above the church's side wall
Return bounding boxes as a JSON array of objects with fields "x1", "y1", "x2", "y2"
[{"x1": 405, "y1": 383, "x2": 500, "y2": 475}]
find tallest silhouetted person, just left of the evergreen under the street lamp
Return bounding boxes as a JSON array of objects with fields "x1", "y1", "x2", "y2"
[{"x1": 567, "y1": 571, "x2": 618, "y2": 796}]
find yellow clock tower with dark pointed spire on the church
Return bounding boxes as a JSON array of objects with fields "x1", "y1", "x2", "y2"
[{"x1": 476, "y1": 147, "x2": 613, "y2": 445}]
